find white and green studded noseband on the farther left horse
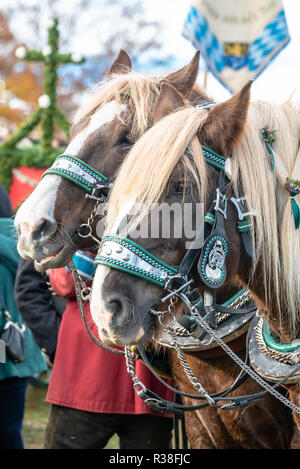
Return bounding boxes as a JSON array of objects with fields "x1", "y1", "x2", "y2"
[{"x1": 42, "y1": 154, "x2": 108, "y2": 193}]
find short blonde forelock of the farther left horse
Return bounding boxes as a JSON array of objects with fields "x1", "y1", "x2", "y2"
[{"x1": 73, "y1": 72, "x2": 163, "y2": 141}]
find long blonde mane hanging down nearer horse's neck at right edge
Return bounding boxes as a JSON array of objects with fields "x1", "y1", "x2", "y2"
[{"x1": 232, "y1": 101, "x2": 300, "y2": 337}]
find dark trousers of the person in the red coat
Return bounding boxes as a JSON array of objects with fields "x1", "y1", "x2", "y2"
[{"x1": 44, "y1": 405, "x2": 172, "y2": 449}]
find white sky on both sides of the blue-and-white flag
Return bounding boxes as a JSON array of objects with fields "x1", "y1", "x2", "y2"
[{"x1": 144, "y1": 0, "x2": 300, "y2": 104}]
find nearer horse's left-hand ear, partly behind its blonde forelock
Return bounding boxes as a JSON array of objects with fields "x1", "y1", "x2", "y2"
[{"x1": 153, "y1": 82, "x2": 185, "y2": 124}]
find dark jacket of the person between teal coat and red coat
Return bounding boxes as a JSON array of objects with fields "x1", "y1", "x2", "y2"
[{"x1": 15, "y1": 259, "x2": 66, "y2": 362}]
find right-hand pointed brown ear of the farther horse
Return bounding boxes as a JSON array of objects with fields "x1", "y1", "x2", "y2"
[{"x1": 165, "y1": 51, "x2": 200, "y2": 97}]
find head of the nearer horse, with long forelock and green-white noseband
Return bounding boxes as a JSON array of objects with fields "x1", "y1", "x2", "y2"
[{"x1": 91, "y1": 79, "x2": 251, "y2": 345}]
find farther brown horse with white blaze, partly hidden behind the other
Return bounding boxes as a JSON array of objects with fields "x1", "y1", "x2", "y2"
[{"x1": 16, "y1": 52, "x2": 296, "y2": 447}]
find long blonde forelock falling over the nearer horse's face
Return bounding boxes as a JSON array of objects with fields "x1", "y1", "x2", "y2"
[{"x1": 106, "y1": 106, "x2": 208, "y2": 232}]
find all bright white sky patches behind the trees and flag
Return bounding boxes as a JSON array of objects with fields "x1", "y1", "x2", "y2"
[{"x1": 0, "y1": 0, "x2": 300, "y2": 104}]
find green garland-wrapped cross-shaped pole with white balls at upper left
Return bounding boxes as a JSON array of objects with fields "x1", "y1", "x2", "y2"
[{"x1": 0, "y1": 18, "x2": 85, "y2": 190}]
